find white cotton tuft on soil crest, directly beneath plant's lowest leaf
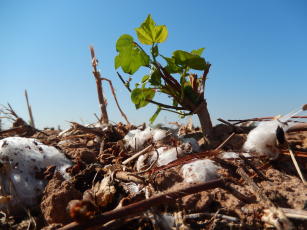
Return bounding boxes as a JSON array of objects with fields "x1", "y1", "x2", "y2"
[{"x1": 124, "y1": 127, "x2": 167, "y2": 151}]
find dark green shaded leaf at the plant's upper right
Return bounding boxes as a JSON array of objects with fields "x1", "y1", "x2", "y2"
[{"x1": 173, "y1": 50, "x2": 206, "y2": 70}]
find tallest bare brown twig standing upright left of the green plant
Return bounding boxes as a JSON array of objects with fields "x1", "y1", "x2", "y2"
[{"x1": 90, "y1": 46, "x2": 109, "y2": 124}]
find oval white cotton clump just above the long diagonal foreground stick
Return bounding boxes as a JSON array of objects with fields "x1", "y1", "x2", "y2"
[{"x1": 180, "y1": 159, "x2": 220, "y2": 183}]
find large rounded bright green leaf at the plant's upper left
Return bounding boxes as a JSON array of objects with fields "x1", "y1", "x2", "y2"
[{"x1": 114, "y1": 34, "x2": 149, "y2": 75}]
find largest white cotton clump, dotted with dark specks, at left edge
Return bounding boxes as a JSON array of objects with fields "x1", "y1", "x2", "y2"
[{"x1": 0, "y1": 137, "x2": 71, "y2": 212}]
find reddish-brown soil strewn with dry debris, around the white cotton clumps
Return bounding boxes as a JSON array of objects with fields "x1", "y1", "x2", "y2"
[{"x1": 0, "y1": 123, "x2": 307, "y2": 230}]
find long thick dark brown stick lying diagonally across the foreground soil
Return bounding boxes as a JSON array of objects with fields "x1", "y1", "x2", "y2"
[{"x1": 59, "y1": 179, "x2": 254, "y2": 230}]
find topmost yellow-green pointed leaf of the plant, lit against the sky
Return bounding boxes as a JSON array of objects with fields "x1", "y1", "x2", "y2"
[{"x1": 135, "y1": 14, "x2": 168, "y2": 45}]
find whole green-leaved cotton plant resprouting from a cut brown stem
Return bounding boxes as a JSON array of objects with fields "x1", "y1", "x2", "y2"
[{"x1": 115, "y1": 15, "x2": 212, "y2": 136}]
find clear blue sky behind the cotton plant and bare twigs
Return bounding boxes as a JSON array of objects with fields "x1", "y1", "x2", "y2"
[{"x1": 0, "y1": 0, "x2": 307, "y2": 128}]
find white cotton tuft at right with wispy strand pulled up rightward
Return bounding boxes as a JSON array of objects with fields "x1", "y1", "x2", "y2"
[{"x1": 243, "y1": 108, "x2": 303, "y2": 159}]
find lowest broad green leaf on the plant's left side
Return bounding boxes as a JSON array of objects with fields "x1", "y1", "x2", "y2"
[{"x1": 131, "y1": 88, "x2": 155, "y2": 109}]
